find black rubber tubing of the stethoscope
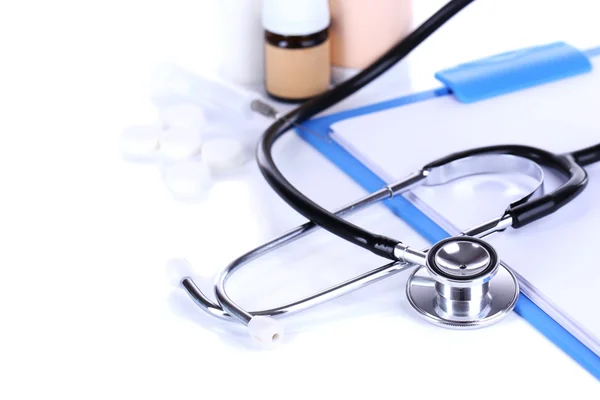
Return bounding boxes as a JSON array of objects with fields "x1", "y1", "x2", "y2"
[{"x1": 257, "y1": 0, "x2": 600, "y2": 260}]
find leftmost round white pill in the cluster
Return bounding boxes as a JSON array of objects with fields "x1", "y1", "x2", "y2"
[{"x1": 121, "y1": 125, "x2": 161, "y2": 161}]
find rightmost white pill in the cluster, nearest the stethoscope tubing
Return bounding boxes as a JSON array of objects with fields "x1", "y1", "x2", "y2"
[{"x1": 202, "y1": 138, "x2": 249, "y2": 172}]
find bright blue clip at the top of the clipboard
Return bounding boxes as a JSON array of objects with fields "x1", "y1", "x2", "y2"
[{"x1": 435, "y1": 42, "x2": 592, "y2": 103}]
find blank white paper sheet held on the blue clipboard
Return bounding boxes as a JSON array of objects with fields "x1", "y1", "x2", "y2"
[{"x1": 332, "y1": 57, "x2": 600, "y2": 355}]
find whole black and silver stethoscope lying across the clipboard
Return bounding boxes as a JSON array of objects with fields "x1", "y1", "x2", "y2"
[{"x1": 173, "y1": 0, "x2": 600, "y2": 348}]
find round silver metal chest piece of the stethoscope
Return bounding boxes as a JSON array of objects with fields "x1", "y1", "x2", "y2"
[{"x1": 406, "y1": 236, "x2": 519, "y2": 329}]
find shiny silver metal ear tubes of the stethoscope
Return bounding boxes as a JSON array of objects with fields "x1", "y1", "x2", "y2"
[{"x1": 181, "y1": 154, "x2": 543, "y2": 325}]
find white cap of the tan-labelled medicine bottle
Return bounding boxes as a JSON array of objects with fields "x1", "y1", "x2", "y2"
[{"x1": 262, "y1": 0, "x2": 331, "y2": 36}]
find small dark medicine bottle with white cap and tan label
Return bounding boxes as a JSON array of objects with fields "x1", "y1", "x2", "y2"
[{"x1": 263, "y1": 0, "x2": 331, "y2": 102}]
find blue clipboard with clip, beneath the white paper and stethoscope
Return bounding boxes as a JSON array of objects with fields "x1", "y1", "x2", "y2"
[{"x1": 296, "y1": 43, "x2": 600, "y2": 380}]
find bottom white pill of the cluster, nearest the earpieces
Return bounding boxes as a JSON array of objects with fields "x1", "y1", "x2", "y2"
[{"x1": 162, "y1": 160, "x2": 212, "y2": 201}]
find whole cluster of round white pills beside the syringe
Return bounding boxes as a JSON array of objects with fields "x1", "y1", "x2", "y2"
[{"x1": 121, "y1": 103, "x2": 251, "y2": 201}]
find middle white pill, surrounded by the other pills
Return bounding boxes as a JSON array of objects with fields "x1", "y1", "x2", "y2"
[{"x1": 158, "y1": 128, "x2": 202, "y2": 161}]
